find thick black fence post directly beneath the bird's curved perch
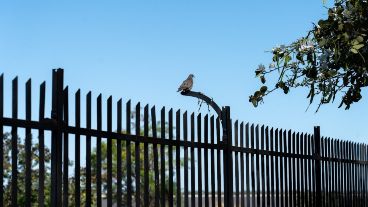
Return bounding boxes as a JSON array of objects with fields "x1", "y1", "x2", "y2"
[{"x1": 222, "y1": 106, "x2": 233, "y2": 207}]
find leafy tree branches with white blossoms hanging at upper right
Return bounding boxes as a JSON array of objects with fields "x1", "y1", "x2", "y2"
[{"x1": 249, "y1": 0, "x2": 368, "y2": 111}]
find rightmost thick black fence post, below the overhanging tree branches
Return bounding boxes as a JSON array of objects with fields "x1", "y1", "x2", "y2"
[{"x1": 314, "y1": 126, "x2": 322, "y2": 206}]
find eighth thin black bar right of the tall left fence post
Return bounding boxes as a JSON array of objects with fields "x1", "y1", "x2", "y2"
[{"x1": 134, "y1": 102, "x2": 141, "y2": 207}]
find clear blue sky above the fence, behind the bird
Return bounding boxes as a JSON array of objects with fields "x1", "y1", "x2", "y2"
[{"x1": 0, "y1": 0, "x2": 368, "y2": 143}]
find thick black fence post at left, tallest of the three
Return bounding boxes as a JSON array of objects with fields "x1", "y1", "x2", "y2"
[{"x1": 51, "y1": 69, "x2": 64, "y2": 207}]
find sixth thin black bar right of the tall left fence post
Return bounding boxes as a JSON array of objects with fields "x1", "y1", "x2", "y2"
[{"x1": 116, "y1": 99, "x2": 123, "y2": 207}]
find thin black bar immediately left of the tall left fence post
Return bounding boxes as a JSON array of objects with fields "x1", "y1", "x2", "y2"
[{"x1": 38, "y1": 82, "x2": 46, "y2": 207}]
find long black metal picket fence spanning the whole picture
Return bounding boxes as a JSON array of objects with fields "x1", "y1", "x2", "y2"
[{"x1": 0, "y1": 69, "x2": 368, "y2": 207}]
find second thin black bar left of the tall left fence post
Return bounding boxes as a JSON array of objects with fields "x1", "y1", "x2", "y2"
[{"x1": 25, "y1": 79, "x2": 32, "y2": 207}]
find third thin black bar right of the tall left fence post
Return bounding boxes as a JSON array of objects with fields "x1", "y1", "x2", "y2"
[{"x1": 86, "y1": 91, "x2": 92, "y2": 207}]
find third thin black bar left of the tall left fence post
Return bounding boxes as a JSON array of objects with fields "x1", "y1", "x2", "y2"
[{"x1": 11, "y1": 77, "x2": 18, "y2": 207}]
